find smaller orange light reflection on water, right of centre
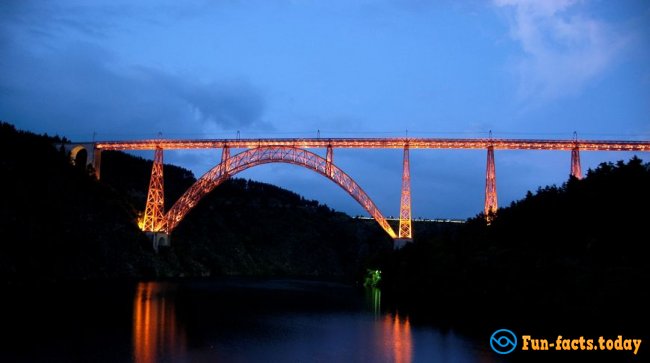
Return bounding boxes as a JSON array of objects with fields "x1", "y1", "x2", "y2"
[{"x1": 379, "y1": 314, "x2": 413, "y2": 363}]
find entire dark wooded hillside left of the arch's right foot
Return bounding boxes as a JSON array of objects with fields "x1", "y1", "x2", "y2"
[{"x1": 0, "y1": 123, "x2": 391, "y2": 282}]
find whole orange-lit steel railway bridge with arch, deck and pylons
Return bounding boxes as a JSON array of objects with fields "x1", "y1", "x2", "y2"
[{"x1": 66, "y1": 133, "x2": 650, "y2": 247}]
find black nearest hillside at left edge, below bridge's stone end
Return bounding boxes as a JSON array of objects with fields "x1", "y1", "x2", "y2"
[{"x1": 0, "y1": 123, "x2": 162, "y2": 281}]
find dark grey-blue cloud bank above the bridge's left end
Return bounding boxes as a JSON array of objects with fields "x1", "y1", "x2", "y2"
[{"x1": 0, "y1": 38, "x2": 269, "y2": 138}]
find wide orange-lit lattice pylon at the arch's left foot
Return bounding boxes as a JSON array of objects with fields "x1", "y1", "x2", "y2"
[{"x1": 142, "y1": 148, "x2": 167, "y2": 232}]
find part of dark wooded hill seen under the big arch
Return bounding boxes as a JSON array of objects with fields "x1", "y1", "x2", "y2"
[{"x1": 168, "y1": 179, "x2": 392, "y2": 278}]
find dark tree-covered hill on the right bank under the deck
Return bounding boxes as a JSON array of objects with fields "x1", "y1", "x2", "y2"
[{"x1": 384, "y1": 158, "x2": 650, "y2": 324}]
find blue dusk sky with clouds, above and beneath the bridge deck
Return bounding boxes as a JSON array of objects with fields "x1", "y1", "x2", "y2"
[{"x1": 0, "y1": 0, "x2": 650, "y2": 218}]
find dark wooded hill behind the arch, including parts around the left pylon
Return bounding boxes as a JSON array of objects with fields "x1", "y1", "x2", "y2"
[{"x1": 102, "y1": 151, "x2": 392, "y2": 279}]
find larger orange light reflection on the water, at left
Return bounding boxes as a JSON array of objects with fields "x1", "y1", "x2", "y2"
[{"x1": 133, "y1": 282, "x2": 186, "y2": 363}]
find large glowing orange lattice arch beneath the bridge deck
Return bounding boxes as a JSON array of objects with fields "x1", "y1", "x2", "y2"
[{"x1": 165, "y1": 146, "x2": 397, "y2": 238}]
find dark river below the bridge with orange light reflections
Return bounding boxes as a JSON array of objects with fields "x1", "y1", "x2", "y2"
[{"x1": 0, "y1": 279, "x2": 499, "y2": 363}]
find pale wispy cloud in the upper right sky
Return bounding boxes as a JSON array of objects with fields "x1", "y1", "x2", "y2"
[{"x1": 494, "y1": 0, "x2": 626, "y2": 101}]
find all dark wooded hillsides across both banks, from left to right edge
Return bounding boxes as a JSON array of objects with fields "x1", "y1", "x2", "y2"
[{"x1": 0, "y1": 123, "x2": 650, "y2": 333}]
